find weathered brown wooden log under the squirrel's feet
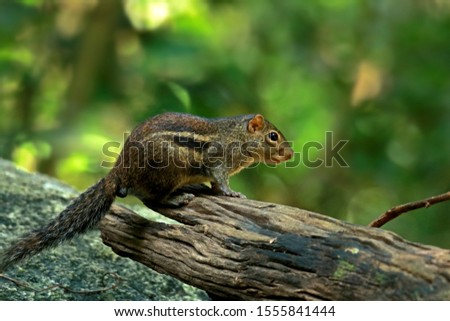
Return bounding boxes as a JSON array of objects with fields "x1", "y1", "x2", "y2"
[{"x1": 100, "y1": 186, "x2": 450, "y2": 300}]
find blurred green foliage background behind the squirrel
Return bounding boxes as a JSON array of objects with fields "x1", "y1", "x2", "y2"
[{"x1": 0, "y1": 0, "x2": 450, "y2": 247}]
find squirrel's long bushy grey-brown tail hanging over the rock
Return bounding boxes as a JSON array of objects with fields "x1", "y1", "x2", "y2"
[{"x1": 0, "y1": 173, "x2": 116, "y2": 272}]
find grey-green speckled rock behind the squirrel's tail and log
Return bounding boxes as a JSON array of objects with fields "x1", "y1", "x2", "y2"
[{"x1": 0, "y1": 158, "x2": 207, "y2": 300}]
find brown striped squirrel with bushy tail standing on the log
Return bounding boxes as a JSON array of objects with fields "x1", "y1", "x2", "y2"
[{"x1": 0, "y1": 113, "x2": 293, "y2": 272}]
